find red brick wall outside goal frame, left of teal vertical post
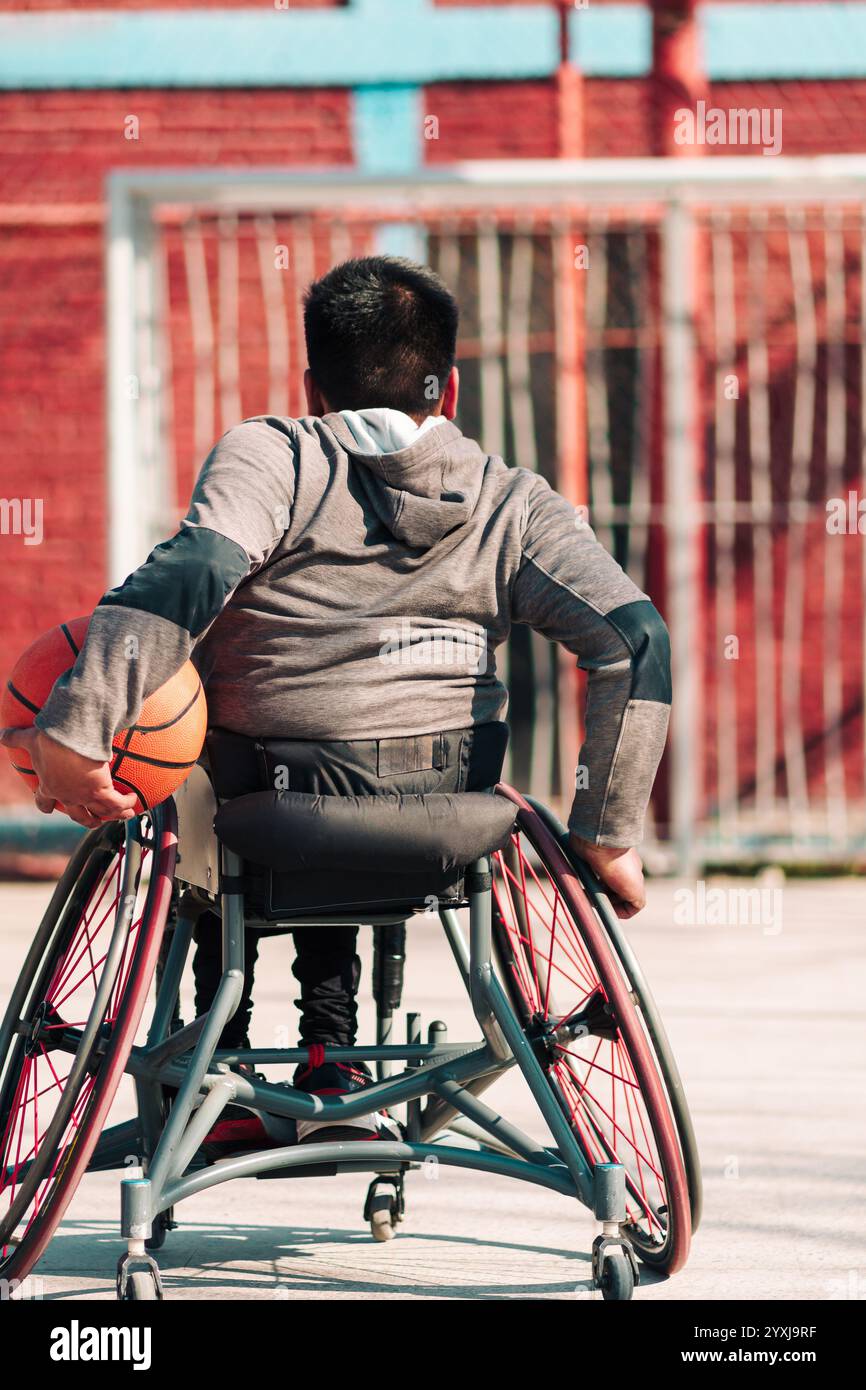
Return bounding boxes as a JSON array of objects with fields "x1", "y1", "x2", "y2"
[{"x1": 0, "y1": 90, "x2": 352, "y2": 801}]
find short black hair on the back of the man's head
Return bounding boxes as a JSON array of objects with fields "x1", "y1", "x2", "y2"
[{"x1": 304, "y1": 256, "x2": 460, "y2": 418}]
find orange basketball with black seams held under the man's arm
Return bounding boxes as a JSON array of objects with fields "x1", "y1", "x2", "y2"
[{"x1": 0, "y1": 617, "x2": 207, "y2": 810}]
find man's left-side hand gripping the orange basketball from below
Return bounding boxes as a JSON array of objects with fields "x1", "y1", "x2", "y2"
[{"x1": 0, "y1": 728, "x2": 136, "y2": 830}]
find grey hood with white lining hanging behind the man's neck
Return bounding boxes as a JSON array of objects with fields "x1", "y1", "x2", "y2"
[{"x1": 324, "y1": 410, "x2": 485, "y2": 549}]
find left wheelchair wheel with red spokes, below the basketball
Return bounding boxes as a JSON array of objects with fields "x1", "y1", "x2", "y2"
[{"x1": 0, "y1": 802, "x2": 177, "y2": 1279}]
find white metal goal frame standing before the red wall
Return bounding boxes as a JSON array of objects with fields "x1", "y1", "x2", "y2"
[{"x1": 106, "y1": 156, "x2": 866, "y2": 872}]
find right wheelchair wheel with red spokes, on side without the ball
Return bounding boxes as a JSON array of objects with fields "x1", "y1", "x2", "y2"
[{"x1": 493, "y1": 785, "x2": 691, "y2": 1273}]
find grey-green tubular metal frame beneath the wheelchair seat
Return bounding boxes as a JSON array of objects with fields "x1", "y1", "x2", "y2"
[{"x1": 118, "y1": 822, "x2": 634, "y2": 1293}]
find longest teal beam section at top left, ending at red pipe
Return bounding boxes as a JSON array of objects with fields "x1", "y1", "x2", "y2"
[{"x1": 0, "y1": 0, "x2": 557, "y2": 89}]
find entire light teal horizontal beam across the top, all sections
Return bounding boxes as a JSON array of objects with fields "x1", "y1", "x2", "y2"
[{"x1": 0, "y1": 0, "x2": 866, "y2": 89}]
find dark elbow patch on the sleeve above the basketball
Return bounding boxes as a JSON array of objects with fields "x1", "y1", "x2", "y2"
[{"x1": 100, "y1": 527, "x2": 250, "y2": 637}]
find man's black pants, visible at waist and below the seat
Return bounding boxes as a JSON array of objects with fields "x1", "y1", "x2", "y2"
[{"x1": 193, "y1": 723, "x2": 507, "y2": 1048}]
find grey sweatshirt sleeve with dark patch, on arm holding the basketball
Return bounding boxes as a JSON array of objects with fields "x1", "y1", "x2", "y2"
[{"x1": 36, "y1": 420, "x2": 295, "y2": 762}]
